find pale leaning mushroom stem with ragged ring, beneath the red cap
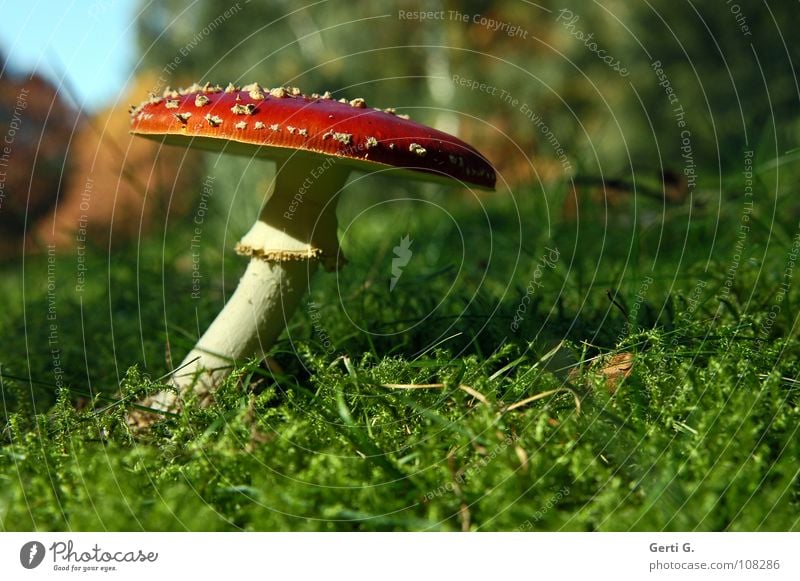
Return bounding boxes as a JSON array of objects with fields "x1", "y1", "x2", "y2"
[{"x1": 142, "y1": 155, "x2": 348, "y2": 411}]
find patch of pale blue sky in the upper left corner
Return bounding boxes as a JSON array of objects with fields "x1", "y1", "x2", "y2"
[{"x1": 0, "y1": 0, "x2": 139, "y2": 111}]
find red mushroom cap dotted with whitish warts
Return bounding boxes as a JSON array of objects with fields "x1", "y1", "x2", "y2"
[{"x1": 131, "y1": 83, "x2": 495, "y2": 189}]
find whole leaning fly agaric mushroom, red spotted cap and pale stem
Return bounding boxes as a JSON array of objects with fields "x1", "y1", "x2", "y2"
[{"x1": 126, "y1": 83, "x2": 495, "y2": 423}]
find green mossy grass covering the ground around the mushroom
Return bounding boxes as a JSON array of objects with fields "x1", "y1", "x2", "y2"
[{"x1": 0, "y1": 163, "x2": 800, "y2": 530}]
